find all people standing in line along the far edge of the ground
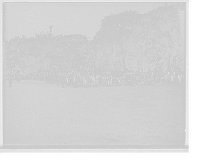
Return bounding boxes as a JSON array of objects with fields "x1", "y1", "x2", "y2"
[{"x1": 8, "y1": 64, "x2": 184, "y2": 88}]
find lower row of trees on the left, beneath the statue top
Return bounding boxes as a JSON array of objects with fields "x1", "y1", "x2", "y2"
[{"x1": 3, "y1": 33, "x2": 88, "y2": 76}]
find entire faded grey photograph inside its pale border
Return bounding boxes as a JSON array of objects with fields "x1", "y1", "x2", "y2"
[{"x1": 2, "y1": 2, "x2": 188, "y2": 149}]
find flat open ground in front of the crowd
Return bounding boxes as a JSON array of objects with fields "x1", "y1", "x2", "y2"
[{"x1": 3, "y1": 80, "x2": 185, "y2": 147}]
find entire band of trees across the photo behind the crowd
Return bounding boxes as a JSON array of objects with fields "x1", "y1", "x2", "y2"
[{"x1": 3, "y1": 5, "x2": 184, "y2": 77}]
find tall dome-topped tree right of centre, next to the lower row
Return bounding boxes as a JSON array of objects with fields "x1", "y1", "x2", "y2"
[{"x1": 95, "y1": 11, "x2": 137, "y2": 70}]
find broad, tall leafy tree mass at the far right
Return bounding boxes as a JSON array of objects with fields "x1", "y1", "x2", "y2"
[{"x1": 126, "y1": 6, "x2": 181, "y2": 70}]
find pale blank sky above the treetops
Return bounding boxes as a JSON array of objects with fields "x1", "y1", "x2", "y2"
[{"x1": 3, "y1": 2, "x2": 179, "y2": 40}]
